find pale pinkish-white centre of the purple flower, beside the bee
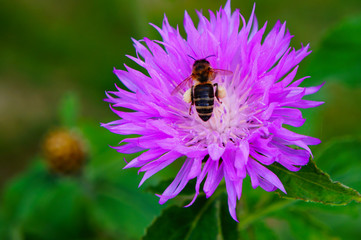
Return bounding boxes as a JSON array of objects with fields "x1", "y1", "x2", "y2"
[{"x1": 180, "y1": 74, "x2": 262, "y2": 147}]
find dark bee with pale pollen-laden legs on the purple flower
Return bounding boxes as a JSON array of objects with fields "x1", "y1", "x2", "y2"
[{"x1": 171, "y1": 56, "x2": 232, "y2": 122}]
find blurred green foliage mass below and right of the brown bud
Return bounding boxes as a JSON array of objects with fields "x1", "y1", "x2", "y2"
[{"x1": 0, "y1": 120, "x2": 161, "y2": 240}]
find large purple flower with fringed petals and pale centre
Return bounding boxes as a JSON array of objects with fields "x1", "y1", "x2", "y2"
[{"x1": 103, "y1": 1, "x2": 322, "y2": 220}]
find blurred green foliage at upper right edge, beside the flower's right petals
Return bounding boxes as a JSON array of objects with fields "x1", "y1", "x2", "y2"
[{"x1": 300, "y1": 14, "x2": 361, "y2": 142}]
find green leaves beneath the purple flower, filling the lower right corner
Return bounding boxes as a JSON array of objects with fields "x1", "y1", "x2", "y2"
[{"x1": 143, "y1": 138, "x2": 361, "y2": 240}]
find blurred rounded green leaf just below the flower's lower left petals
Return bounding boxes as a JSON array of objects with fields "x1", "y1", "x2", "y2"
[{"x1": 90, "y1": 180, "x2": 162, "y2": 239}]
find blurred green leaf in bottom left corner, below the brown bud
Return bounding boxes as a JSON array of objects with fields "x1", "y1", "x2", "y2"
[{"x1": 0, "y1": 161, "x2": 93, "y2": 240}]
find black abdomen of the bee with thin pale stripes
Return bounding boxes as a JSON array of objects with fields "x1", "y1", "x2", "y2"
[{"x1": 193, "y1": 83, "x2": 214, "y2": 122}]
